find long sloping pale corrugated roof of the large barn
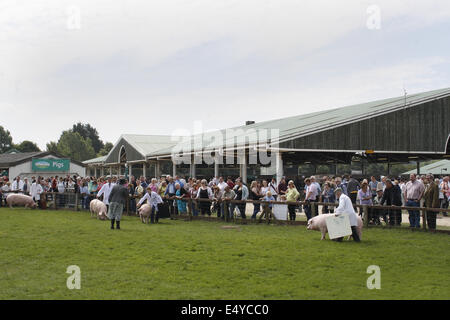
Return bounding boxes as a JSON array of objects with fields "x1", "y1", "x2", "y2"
[{"x1": 146, "y1": 88, "x2": 450, "y2": 157}]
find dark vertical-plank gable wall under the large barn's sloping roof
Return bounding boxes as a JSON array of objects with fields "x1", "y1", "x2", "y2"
[{"x1": 281, "y1": 97, "x2": 450, "y2": 152}]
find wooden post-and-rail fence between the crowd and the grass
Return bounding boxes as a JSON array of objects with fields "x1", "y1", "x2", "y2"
[{"x1": 3, "y1": 191, "x2": 450, "y2": 233}]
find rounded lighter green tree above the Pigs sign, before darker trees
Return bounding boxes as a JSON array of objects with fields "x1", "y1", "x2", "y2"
[{"x1": 57, "y1": 130, "x2": 96, "y2": 161}]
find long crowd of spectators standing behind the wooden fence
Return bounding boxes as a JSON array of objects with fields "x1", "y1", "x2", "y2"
[{"x1": 0, "y1": 174, "x2": 450, "y2": 229}]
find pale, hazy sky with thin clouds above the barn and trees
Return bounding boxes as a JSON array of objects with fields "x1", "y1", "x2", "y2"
[{"x1": 0, "y1": 0, "x2": 450, "y2": 150}]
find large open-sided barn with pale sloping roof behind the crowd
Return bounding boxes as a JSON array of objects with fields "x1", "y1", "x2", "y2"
[{"x1": 84, "y1": 88, "x2": 450, "y2": 181}]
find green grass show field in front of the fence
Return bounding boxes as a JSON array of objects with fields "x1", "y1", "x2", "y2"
[{"x1": 0, "y1": 208, "x2": 450, "y2": 299}]
